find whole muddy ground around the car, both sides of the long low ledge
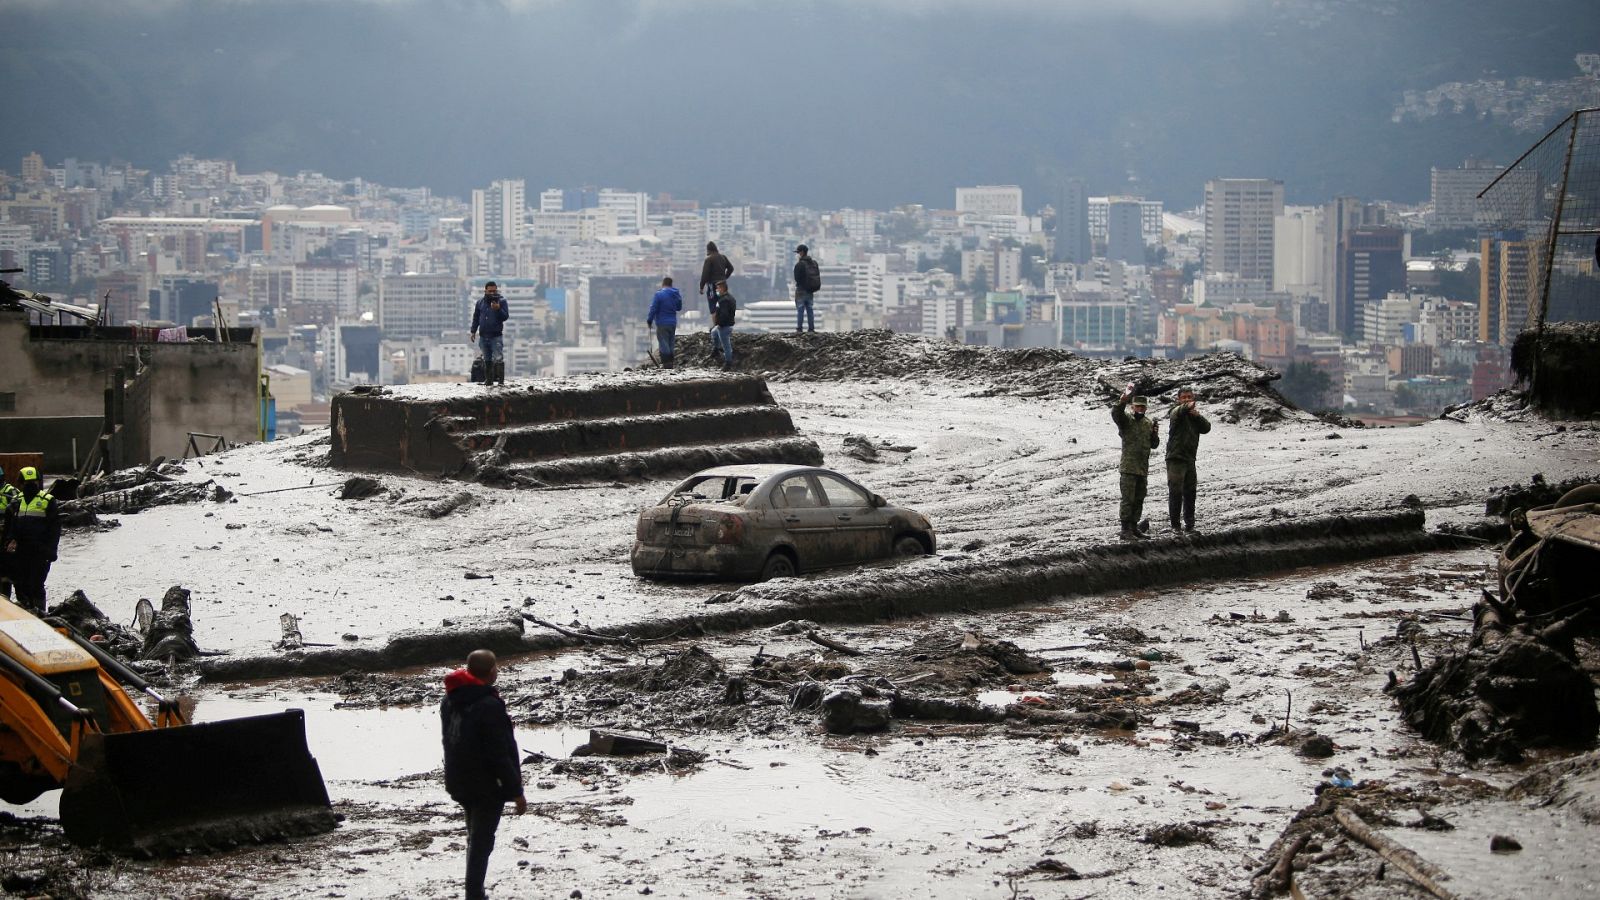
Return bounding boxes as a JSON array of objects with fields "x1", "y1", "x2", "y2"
[{"x1": 9, "y1": 344, "x2": 1600, "y2": 897}]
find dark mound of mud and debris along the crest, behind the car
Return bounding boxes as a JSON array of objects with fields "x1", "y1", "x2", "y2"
[{"x1": 678, "y1": 330, "x2": 1302, "y2": 421}]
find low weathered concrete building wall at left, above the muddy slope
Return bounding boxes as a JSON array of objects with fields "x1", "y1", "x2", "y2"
[{"x1": 0, "y1": 311, "x2": 261, "y2": 458}]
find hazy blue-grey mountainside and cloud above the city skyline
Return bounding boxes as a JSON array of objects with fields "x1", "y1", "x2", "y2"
[{"x1": 0, "y1": 0, "x2": 1600, "y2": 208}]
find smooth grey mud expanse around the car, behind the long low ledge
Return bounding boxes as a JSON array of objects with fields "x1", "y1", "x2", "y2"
[{"x1": 50, "y1": 378, "x2": 1600, "y2": 652}]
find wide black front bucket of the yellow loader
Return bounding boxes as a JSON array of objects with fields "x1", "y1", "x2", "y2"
[{"x1": 61, "y1": 709, "x2": 336, "y2": 857}]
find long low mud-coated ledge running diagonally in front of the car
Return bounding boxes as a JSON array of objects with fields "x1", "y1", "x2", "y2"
[{"x1": 200, "y1": 509, "x2": 1453, "y2": 681}]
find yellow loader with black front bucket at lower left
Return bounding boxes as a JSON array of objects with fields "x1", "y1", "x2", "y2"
[{"x1": 0, "y1": 602, "x2": 336, "y2": 857}]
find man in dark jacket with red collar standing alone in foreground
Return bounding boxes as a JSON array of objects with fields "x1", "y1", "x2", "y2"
[{"x1": 438, "y1": 650, "x2": 528, "y2": 900}]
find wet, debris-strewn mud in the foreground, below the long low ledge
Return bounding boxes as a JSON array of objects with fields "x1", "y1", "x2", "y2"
[{"x1": 12, "y1": 551, "x2": 1582, "y2": 897}]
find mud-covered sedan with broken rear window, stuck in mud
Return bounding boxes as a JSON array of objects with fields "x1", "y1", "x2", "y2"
[{"x1": 634, "y1": 464, "x2": 938, "y2": 581}]
